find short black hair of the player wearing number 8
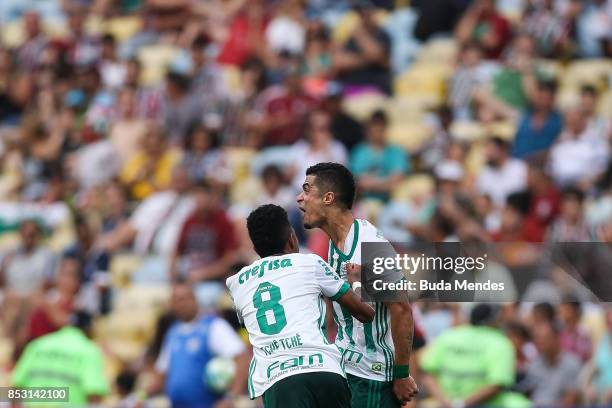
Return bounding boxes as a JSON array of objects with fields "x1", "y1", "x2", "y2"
[{"x1": 247, "y1": 204, "x2": 291, "y2": 258}]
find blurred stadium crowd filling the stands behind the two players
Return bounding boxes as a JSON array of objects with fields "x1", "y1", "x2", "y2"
[{"x1": 0, "y1": 0, "x2": 612, "y2": 407}]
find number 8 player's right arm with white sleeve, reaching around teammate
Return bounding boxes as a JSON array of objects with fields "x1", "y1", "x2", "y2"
[{"x1": 315, "y1": 256, "x2": 374, "y2": 323}]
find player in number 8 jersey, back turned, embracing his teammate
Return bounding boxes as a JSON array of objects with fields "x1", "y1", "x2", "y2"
[{"x1": 226, "y1": 204, "x2": 374, "y2": 408}]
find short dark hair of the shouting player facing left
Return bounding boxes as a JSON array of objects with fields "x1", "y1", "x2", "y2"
[{"x1": 306, "y1": 163, "x2": 355, "y2": 210}]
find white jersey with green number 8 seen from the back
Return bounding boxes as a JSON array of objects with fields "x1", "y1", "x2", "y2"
[{"x1": 226, "y1": 254, "x2": 349, "y2": 398}]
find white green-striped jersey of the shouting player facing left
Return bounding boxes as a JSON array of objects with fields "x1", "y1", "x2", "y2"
[{"x1": 328, "y1": 219, "x2": 395, "y2": 381}]
